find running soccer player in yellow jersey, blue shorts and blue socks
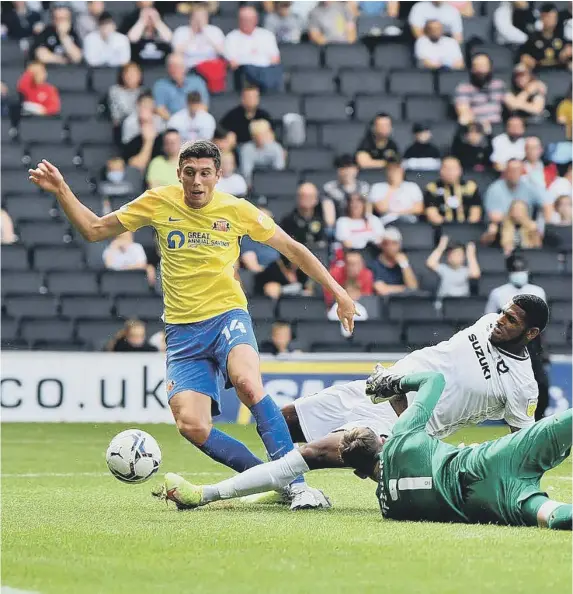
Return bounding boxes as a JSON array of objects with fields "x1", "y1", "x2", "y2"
[{"x1": 29, "y1": 141, "x2": 355, "y2": 509}]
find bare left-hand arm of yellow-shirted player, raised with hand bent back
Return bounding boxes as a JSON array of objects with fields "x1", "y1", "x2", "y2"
[{"x1": 28, "y1": 159, "x2": 127, "y2": 241}]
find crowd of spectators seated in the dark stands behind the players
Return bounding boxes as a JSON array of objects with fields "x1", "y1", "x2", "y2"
[{"x1": 2, "y1": 1, "x2": 572, "y2": 353}]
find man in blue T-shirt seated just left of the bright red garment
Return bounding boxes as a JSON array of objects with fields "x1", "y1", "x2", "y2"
[{"x1": 153, "y1": 54, "x2": 209, "y2": 120}]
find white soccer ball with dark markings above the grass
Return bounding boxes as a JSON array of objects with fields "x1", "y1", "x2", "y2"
[{"x1": 105, "y1": 429, "x2": 161, "y2": 483}]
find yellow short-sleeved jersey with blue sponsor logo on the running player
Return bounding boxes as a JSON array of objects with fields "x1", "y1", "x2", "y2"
[{"x1": 115, "y1": 186, "x2": 276, "y2": 324}]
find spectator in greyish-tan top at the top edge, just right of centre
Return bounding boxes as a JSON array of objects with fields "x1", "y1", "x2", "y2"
[{"x1": 308, "y1": 2, "x2": 356, "y2": 45}]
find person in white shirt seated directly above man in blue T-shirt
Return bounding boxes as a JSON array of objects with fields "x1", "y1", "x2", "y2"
[{"x1": 171, "y1": 6, "x2": 225, "y2": 68}]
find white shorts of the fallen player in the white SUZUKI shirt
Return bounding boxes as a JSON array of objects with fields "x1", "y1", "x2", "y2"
[{"x1": 294, "y1": 380, "x2": 398, "y2": 442}]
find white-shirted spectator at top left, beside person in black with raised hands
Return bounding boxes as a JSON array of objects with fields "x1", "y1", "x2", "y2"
[{"x1": 84, "y1": 12, "x2": 131, "y2": 66}]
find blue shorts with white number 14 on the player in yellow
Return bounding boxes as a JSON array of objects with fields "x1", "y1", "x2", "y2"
[{"x1": 165, "y1": 309, "x2": 259, "y2": 416}]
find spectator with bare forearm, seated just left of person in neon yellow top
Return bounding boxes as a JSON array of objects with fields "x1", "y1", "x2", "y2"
[{"x1": 121, "y1": 93, "x2": 165, "y2": 172}]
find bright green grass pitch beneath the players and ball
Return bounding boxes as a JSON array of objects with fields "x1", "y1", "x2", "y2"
[{"x1": 2, "y1": 424, "x2": 571, "y2": 594}]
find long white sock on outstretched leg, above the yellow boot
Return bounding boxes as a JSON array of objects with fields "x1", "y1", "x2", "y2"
[{"x1": 203, "y1": 450, "x2": 309, "y2": 503}]
